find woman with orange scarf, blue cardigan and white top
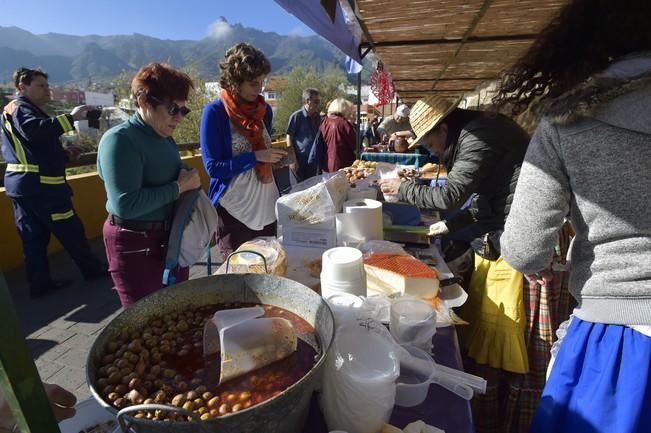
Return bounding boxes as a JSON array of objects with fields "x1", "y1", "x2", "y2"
[{"x1": 201, "y1": 43, "x2": 286, "y2": 257}]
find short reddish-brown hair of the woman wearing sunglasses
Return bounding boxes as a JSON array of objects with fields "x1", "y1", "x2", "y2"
[{"x1": 131, "y1": 63, "x2": 194, "y2": 107}]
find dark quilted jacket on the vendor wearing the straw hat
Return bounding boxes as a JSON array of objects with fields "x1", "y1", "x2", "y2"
[{"x1": 399, "y1": 109, "x2": 529, "y2": 233}]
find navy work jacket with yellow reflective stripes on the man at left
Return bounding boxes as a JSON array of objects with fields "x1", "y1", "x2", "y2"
[{"x1": 2, "y1": 97, "x2": 74, "y2": 198}]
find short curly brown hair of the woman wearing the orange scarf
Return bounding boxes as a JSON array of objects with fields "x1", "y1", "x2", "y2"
[{"x1": 219, "y1": 42, "x2": 271, "y2": 89}]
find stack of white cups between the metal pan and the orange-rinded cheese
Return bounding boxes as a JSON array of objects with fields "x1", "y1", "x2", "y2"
[{"x1": 321, "y1": 247, "x2": 366, "y2": 299}]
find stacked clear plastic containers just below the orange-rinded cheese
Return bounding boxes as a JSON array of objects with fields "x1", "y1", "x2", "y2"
[{"x1": 389, "y1": 298, "x2": 436, "y2": 349}]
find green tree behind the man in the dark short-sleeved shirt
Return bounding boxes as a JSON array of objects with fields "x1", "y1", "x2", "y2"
[{"x1": 273, "y1": 66, "x2": 347, "y2": 135}]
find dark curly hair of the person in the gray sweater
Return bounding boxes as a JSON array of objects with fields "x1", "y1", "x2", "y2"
[{"x1": 493, "y1": 0, "x2": 651, "y2": 115}]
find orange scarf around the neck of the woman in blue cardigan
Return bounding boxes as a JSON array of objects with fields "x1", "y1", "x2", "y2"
[{"x1": 221, "y1": 89, "x2": 273, "y2": 183}]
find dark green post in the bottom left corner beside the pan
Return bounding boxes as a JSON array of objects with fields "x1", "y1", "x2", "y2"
[{"x1": 0, "y1": 273, "x2": 61, "y2": 433}]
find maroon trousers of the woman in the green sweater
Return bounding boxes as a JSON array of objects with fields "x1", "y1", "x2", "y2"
[{"x1": 103, "y1": 220, "x2": 190, "y2": 308}]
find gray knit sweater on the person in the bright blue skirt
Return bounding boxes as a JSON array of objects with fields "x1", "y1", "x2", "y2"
[{"x1": 501, "y1": 58, "x2": 651, "y2": 325}]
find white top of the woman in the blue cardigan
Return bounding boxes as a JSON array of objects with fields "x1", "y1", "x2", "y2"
[{"x1": 219, "y1": 125, "x2": 279, "y2": 230}]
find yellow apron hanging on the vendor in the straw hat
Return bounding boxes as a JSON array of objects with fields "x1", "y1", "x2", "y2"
[{"x1": 459, "y1": 254, "x2": 529, "y2": 374}]
